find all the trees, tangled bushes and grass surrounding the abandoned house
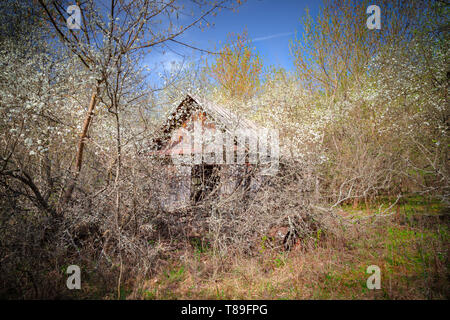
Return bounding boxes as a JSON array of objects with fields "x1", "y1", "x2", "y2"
[{"x1": 0, "y1": 0, "x2": 450, "y2": 299}]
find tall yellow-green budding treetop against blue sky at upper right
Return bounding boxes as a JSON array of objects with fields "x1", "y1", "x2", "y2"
[{"x1": 291, "y1": 0, "x2": 427, "y2": 105}]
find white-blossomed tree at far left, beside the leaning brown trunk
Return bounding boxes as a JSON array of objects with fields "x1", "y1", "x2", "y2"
[{"x1": 0, "y1": 2, "x2": 93, "y2": 214}]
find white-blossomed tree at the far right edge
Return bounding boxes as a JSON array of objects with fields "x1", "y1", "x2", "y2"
[{"x1": 363, "y1": 3, "x2": 450, "y2": 204}]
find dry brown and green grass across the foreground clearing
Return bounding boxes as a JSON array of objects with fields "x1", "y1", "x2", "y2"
[{"x1": 125, "y1": 197, "x2": 450, "y2": 299}]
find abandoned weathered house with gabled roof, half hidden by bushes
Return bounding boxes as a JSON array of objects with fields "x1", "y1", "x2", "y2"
[{"x1": 151, "y1": 95, "x2": 278, "y2": 211}]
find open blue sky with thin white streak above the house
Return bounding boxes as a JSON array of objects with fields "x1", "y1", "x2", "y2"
[{"x1": 145, "y1": 0, "x2": 321, "y2": 80}]
